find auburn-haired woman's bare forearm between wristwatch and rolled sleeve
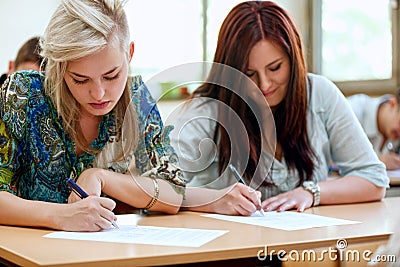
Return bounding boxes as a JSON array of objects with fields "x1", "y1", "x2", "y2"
[{"x1": 318, "y1": 176, "x2": 386, "y2": 205}]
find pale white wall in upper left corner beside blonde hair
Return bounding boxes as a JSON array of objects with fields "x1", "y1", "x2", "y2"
[{"x1": 0, "y1": 0, "x2": 60, "y2": 74}]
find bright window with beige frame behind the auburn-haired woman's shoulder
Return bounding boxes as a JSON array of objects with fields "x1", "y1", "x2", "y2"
[{"x1": 312, "y1": 0, "x2": 398, "y2": 94}]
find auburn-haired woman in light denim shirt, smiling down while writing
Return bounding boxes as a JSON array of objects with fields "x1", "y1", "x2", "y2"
[{"x1": 171, "y1": 1, "x2": 389, "y2": 214}]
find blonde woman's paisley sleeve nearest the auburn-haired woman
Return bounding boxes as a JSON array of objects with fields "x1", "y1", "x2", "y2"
[{"x1": 132, "y1": 76, "x2": 186, "y2": 194}]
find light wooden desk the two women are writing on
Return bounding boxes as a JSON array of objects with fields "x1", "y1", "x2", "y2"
[{"x1": 0, "y1": 197, "x2": 400, "y2": 267}]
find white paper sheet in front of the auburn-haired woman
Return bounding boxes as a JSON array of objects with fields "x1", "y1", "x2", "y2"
[{"x1": 202, "y1": 211, "x2": 360, "y2": 231}]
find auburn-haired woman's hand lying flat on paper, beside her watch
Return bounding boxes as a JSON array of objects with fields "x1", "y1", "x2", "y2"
[{"x1": 261, "y1": 187, "x2": 314, "y2": 212}]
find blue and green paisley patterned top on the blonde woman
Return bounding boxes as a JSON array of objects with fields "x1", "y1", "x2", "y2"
[{"x1": 0, "y1": 71, "x2": 185, "y2": 203}]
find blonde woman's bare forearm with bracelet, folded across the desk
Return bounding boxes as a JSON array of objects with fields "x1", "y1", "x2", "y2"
[{"x1": 94, "y1": 170, "x2": 183, "y2": 214}]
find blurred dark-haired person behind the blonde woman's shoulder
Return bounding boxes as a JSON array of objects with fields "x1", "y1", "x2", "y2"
[{"x1": 0, "y1": 36, "x2": 43, "y2": 87}]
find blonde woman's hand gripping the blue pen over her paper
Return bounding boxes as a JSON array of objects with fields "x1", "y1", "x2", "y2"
[{"x1": 53, "y1": 196, "x2": 117, "y2": 232}]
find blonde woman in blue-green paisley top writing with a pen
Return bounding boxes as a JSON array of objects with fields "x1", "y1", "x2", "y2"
[{"x1": 0, "y1": 0, "x2": 185, "y2": 231}]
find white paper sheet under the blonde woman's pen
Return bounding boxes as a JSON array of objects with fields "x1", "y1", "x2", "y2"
[{"x1": 43, "y1": 215, "x2": 228, "y2": 247}]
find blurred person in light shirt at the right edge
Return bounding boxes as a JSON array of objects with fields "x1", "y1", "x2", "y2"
[{"x1": 347, "y1": 90, "x2": 400, "y2": 170}]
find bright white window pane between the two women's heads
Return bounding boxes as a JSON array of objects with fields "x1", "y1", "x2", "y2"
[{"x1": 125, "y1": 0, "x2": 203, "y2": 81}]
